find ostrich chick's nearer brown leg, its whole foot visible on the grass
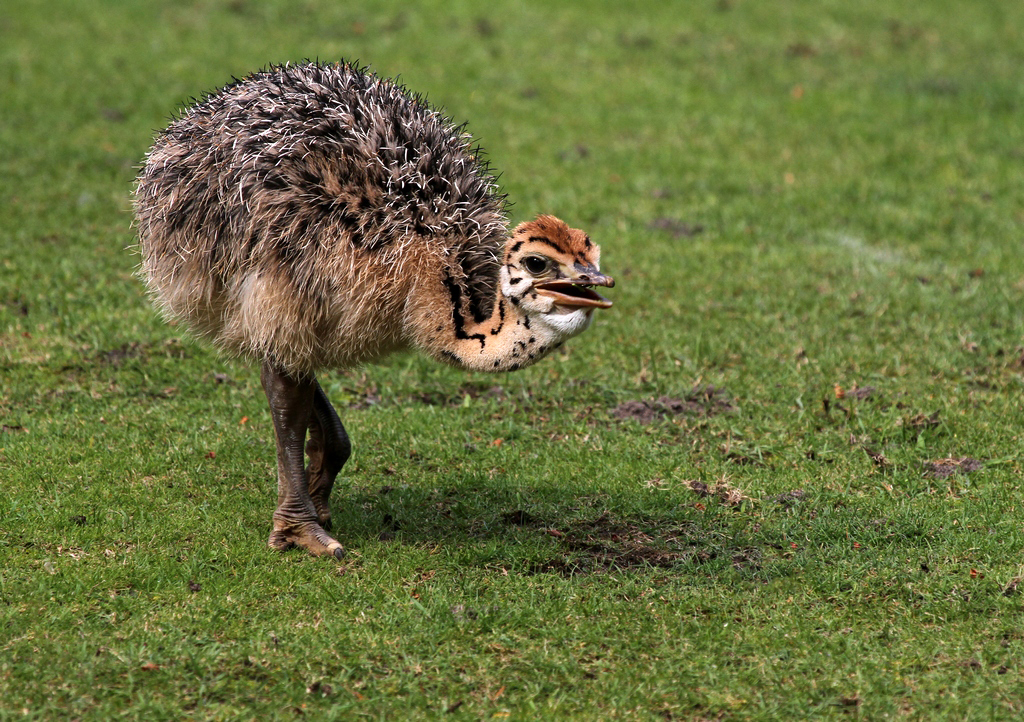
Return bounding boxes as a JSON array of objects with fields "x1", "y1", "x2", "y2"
[{"x1": 260, "y1": 363, "x2": 345, "y2": 559}]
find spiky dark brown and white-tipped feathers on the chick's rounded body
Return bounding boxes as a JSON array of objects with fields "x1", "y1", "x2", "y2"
[{"x1": 135, "y1": 63, "x2": 507, "y2": 371}]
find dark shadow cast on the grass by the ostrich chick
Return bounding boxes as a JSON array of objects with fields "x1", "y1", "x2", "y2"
[{"x1": 319, "y1": 483, "x2": 785, "y2": 580}]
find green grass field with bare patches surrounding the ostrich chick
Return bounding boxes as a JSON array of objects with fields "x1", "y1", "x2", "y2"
[{"x1": 0, "y1": 0, "x2": 1024, "y2": 720}]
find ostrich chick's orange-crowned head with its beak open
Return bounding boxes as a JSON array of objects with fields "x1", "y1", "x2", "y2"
[{"x1": 501, "y1": 215, "x2": 615, "y2": 338}]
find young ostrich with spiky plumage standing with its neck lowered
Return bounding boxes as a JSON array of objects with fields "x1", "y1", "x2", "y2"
[{"x1": 134, "y1": 63, "x2": 614, "y2": 558}]
